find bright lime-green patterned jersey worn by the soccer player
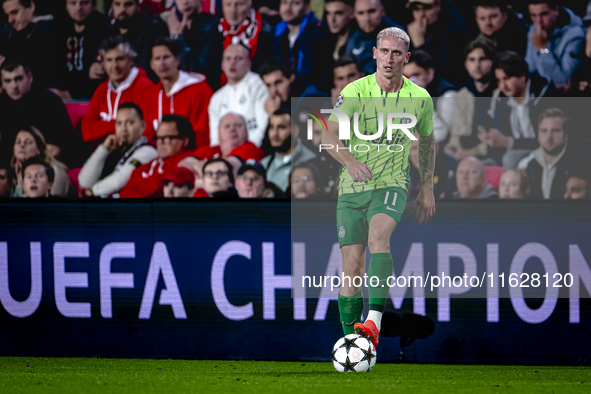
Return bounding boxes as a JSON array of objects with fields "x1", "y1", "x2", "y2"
[{"x1": 328, "y1": 74, "x2": 433, "y2": 195}]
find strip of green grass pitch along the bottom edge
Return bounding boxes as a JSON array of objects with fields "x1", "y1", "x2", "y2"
[{"x1": 0, "y1": 357, "x2": 591, "y2": 394}]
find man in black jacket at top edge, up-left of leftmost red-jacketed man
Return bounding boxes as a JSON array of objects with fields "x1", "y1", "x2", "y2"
[{"x1": 58, "y1": 0, "x2": 109, "y2": 100}]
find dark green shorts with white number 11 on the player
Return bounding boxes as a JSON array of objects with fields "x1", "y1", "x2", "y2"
[{"x1": 337, "y1": 187, "x2": 407, "y2": 247}]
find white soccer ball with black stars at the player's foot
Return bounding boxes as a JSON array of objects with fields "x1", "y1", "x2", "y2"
[{"x1": 332, "y1": 334, "x2": 376, "y2": 372}]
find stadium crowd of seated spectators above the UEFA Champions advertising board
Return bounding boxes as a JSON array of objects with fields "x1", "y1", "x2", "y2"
[{"x1": 0, "y1": 0, "x2": 591, "y2": 199}]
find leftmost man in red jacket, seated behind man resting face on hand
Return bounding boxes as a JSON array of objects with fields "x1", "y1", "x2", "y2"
[{"x1": 82, "y1": 36, "x2": 154, "y2": 142}]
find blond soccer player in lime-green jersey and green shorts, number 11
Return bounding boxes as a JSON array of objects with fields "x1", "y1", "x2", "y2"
[{"x1": 322, "y1": 27, "x2": 435, "y2": 345}]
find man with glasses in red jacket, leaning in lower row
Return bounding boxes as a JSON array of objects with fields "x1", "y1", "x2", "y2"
[{"x1": 120, "y1": 115, "x2": 195, "y2": 198}]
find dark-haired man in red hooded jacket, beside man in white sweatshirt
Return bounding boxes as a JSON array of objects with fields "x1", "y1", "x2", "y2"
[{"x1": 147, "y1": 37, "x2": 213, "y2": 147}]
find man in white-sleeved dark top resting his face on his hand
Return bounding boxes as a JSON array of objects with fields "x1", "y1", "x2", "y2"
[{"x1": 78, "y1": 103, "x2": 158, "y2": 197}]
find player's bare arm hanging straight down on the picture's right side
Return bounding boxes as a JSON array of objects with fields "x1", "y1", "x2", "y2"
[{"x1": 413, "y1": 98, "x2": 435, "y2": 223}]
